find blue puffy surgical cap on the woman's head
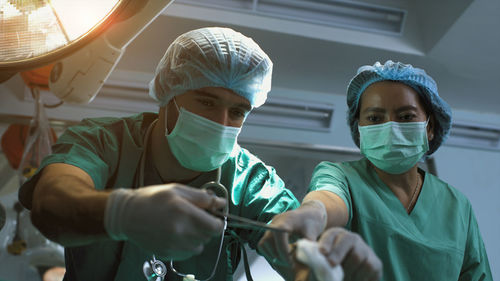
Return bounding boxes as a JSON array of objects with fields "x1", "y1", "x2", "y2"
[{"x1": 347, "y1": 60, "x2": 451, "y2": 155}]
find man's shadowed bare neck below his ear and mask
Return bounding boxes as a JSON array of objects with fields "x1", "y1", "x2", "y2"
[{"x1": 150, "y1": 114, "x2": 201, "y2": 183}]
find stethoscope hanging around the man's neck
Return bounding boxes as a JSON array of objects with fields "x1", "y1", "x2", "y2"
[{"x1": 137, "y1": 119, "x2": 229, "y2": 281}]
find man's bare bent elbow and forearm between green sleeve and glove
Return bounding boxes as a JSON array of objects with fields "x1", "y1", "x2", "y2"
[{"x1": 31, "y1": 163, "x2": 110, "y2": 246}]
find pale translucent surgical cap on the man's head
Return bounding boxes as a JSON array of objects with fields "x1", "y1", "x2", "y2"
[{"x1": 149, "y1": 27, "x2": 273, "y2": 107}]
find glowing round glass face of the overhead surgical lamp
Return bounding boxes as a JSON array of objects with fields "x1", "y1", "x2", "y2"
[{"x1": 0, "y1": 0, "x2": 123, "y2": 75}]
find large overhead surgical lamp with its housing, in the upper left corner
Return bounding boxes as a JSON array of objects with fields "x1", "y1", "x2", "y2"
[{"x1": 0, "y1": 0, "x2": 173, "y2": 103}]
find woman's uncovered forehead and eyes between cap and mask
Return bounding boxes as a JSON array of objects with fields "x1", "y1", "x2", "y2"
[{"x1": 359, "y1": 81, "x2": 433, "y2": 139}]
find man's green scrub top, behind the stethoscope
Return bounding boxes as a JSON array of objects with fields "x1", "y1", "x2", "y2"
[{"x1": 19, "y1": 113, "x2": 299, "y2": 281}]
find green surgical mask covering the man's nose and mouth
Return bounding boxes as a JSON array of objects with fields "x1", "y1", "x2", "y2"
[{"x1": 165, "y1": 101, "x2": 241, "y2": 172}]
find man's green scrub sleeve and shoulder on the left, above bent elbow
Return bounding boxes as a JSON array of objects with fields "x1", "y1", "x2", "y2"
[{"x1": 19, "y1": 114, "x2": 148, "y2": 208}]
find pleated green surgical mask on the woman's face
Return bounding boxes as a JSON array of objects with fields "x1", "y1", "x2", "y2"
[{"x1": 358, "y1": 121, "x2": 429, "y2": 174}]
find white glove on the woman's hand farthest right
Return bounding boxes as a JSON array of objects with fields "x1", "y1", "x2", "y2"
[{"x1": 318, "y1": 227, "x2": 382, "y2": 281}]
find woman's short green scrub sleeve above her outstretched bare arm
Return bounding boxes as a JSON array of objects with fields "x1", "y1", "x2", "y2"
[{"x1": 308, "y1": 161, "x2": 352, "y2": 223}]
